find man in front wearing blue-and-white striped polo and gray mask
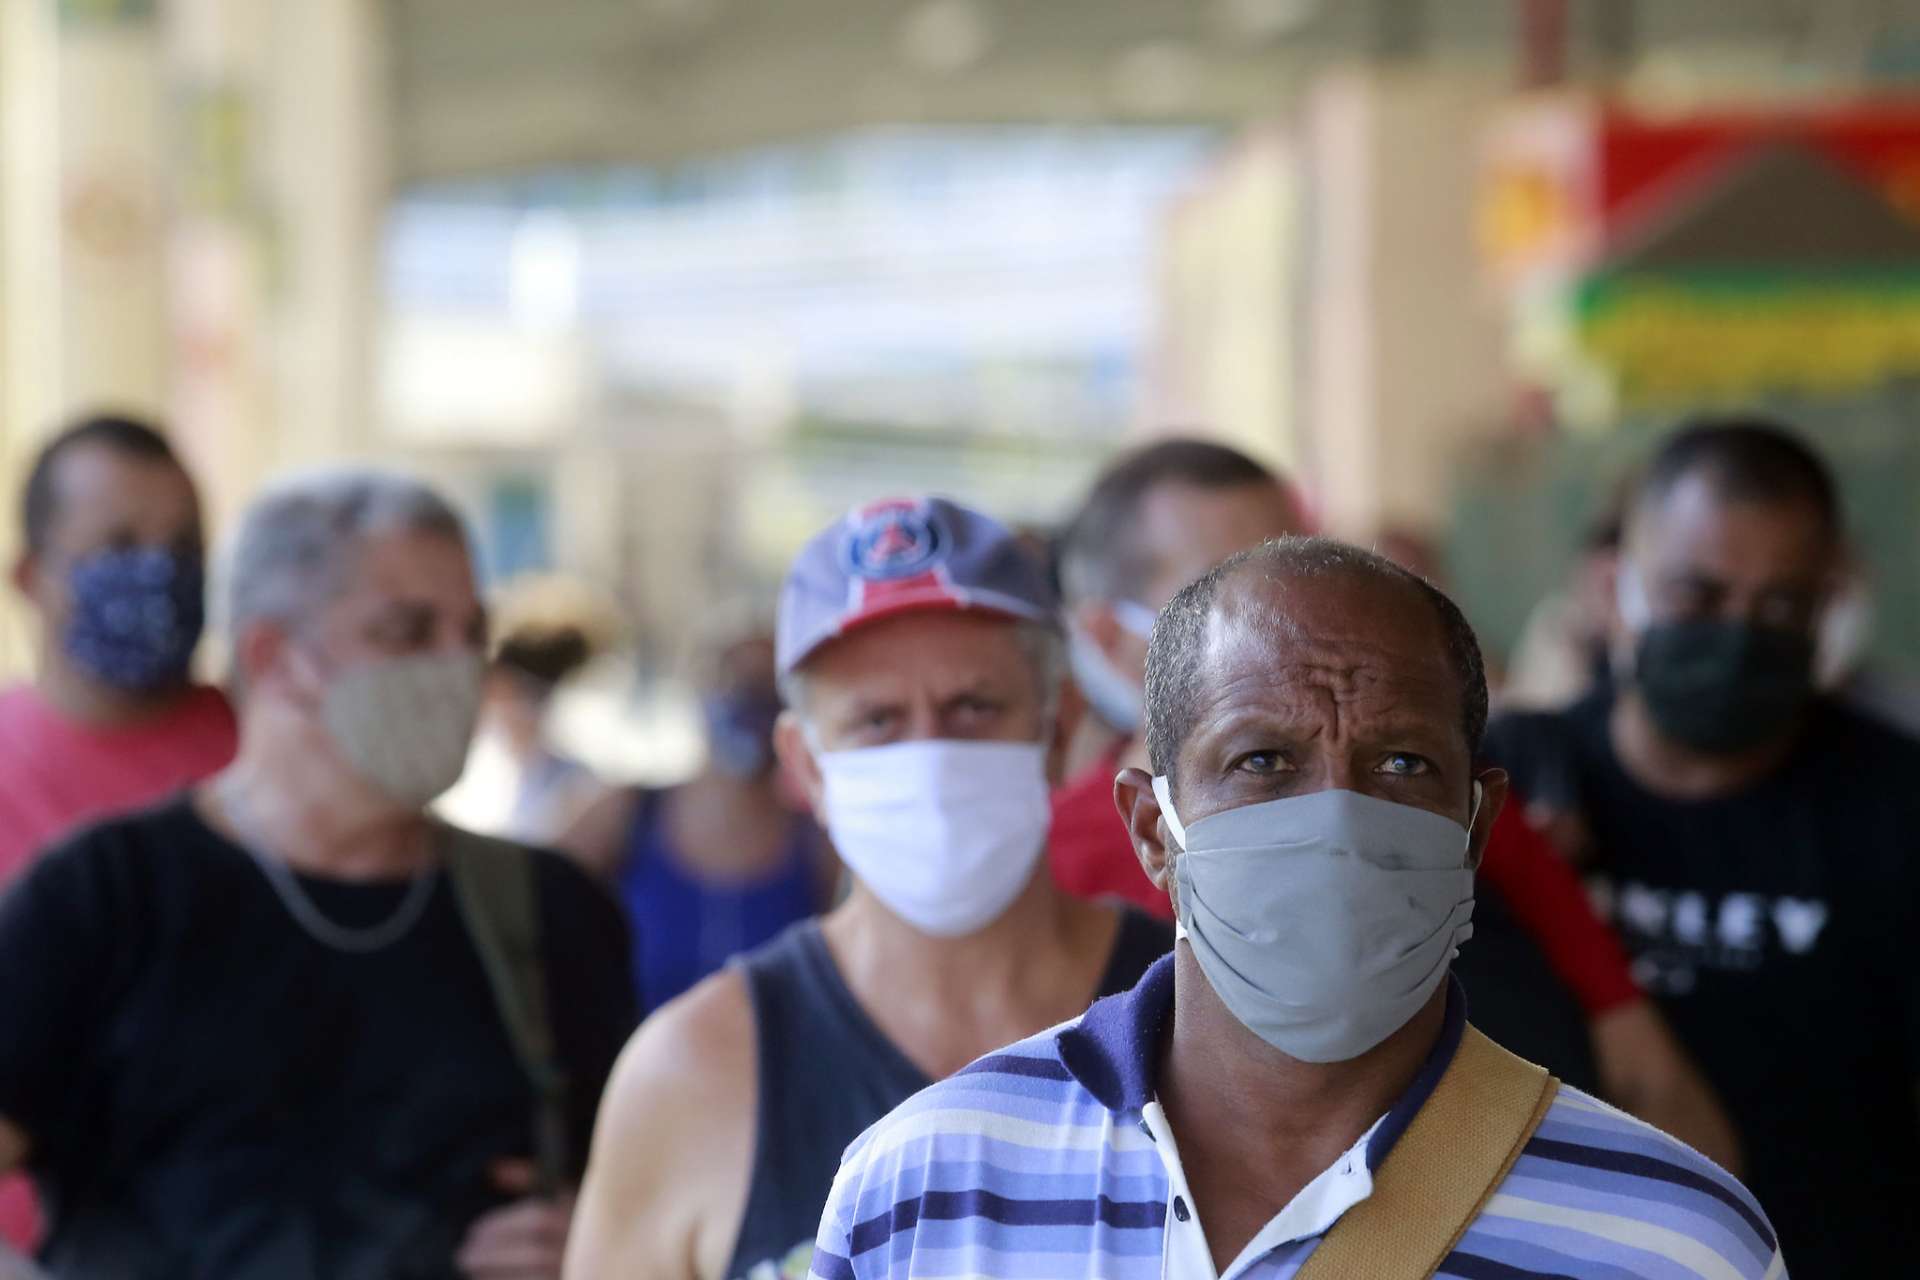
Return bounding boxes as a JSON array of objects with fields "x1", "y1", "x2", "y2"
[{"x1": 812, "y1": 537, "x2": 1781, "y2": 1280}]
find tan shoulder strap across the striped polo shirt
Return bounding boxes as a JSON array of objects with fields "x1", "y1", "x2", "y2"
[{"x1": 1294, "y1": 1027, "x2": 1559, "y2": 1280}]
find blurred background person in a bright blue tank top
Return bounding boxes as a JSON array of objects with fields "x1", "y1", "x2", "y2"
[{"x1": 561, "y1": 631, "x2": 839, "y2": 1011}]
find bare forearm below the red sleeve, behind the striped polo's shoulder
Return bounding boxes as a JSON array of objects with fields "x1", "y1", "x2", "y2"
[{"x1": 1592, "y1": 1000, "x2": 1743, "y2": 1178}]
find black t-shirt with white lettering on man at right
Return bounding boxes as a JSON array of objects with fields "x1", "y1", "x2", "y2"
[{"x1": 1488, "y1": 699, "x2": 1920, "y2": 1276}]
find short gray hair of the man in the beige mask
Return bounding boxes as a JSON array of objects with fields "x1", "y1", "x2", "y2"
[{"x1": 225, "y1": 468, "x2": 470, "y2": 641}]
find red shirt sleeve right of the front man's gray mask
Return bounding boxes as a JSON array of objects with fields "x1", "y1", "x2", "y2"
[{"x1": 1480, "y1": 794, "x2": 1642, "y2": 1017}]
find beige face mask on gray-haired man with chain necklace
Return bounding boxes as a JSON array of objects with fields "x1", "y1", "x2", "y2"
[{"x1": 321, "y1": 652, "x2": 486, "y2": 808}]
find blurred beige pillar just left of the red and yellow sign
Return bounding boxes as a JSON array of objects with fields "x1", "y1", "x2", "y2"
[{"x1": 1302, "y1": 69, "x2": 1511, "y2": 535}]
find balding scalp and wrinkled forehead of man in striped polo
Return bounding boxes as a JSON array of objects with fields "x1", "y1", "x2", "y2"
[{"x1": 1146, "y1": 537, "x2": 1486, "y2": 775}]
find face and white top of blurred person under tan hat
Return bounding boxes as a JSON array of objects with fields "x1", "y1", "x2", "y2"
[{"x1": 480, "y1": 624, "x2": 607, "y2": 846}]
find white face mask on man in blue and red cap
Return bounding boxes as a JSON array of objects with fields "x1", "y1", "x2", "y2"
[{"x1": 818, "y1": 739, "x2": 1052, "y2": 938}]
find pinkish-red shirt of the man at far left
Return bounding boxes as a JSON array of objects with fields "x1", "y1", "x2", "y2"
[{"x1": 0, "y1": 685, "x2": 240, "y2": 1249}]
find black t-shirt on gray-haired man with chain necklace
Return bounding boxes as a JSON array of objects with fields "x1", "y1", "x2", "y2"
[{"x1": 0, "y1": 800, "x2": 634, "y2": 1280}]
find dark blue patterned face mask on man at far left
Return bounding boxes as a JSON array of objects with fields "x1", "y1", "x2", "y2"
[{"x1": 61, "y1": 547, "x2": 207, "y2": 693}]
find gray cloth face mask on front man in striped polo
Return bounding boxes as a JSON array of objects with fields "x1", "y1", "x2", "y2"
[{"x1": 1154, "y1": 777, "x2": 1480, "y2": 1063}]
